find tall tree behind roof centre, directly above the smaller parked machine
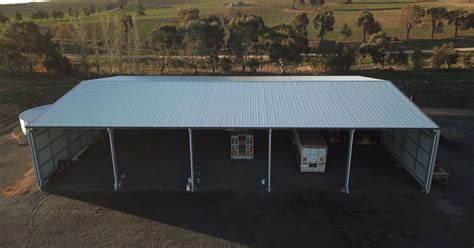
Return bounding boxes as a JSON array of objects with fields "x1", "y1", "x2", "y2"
[{"x1": 226, "y1": 15, "x2": 266, "y2": 72}]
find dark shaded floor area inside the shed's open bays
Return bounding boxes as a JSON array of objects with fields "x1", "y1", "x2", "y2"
[{"x1": 47, "y1": 129, "x2": 421, "y2": 192}]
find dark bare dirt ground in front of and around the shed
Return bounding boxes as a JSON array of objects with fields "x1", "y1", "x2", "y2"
[{"x1": 0, "y1": 116, "x2": 474, "y2": 247}]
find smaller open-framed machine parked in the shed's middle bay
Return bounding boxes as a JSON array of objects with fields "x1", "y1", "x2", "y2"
[{"x1": 230, "y1": 130, "x2": 254, "y2": 159}]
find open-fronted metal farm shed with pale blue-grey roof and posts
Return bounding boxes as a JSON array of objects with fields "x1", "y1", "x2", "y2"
[{"x1": 19, "y1": 76, "x2": 440, "y2": 193}]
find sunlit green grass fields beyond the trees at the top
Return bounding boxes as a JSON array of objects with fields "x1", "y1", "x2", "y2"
[{"x1": 0, "y1": 0, "x2": 474, "y2": 41}]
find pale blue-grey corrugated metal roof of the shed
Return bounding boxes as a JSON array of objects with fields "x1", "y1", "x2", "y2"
[{"x1": 30, "y1": 76, "x2": 438, "y2": 129}]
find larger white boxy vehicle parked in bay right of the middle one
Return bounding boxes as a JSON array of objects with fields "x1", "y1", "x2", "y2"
[{"x1": 293, "y1": 129, "x2": 328, "y2": 172}]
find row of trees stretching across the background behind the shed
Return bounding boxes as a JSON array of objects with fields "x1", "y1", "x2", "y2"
[{"x1": 0, "y1": 5, "x2": 472, "y2": 74}]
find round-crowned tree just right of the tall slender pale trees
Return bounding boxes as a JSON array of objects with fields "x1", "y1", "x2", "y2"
[{"x1": 150, "y1": 24, "x2": 183, "y2": 74}]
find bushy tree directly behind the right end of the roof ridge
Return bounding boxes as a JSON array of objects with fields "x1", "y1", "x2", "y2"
[{"x1": 360, "y1": 31, "x2": 391, "y2": 67}]
